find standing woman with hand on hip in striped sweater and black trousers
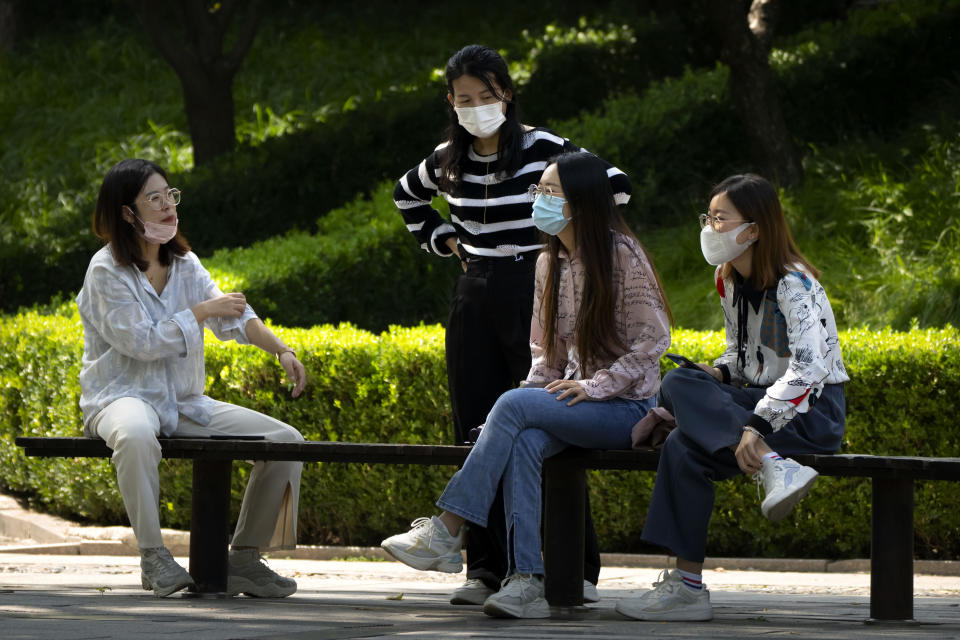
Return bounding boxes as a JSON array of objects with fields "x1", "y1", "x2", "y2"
[{"x1": 394, "y1": 45, "x2": 630, "y2": 604}]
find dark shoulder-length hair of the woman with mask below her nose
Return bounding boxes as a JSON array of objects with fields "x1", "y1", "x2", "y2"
[{"x1": 93, "y1": 159, "x2": 190, "y2": 271}]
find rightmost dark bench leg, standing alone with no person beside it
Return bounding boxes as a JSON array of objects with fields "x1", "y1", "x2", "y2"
[{"x1": 870, "y1": 478, "x2": 913, "y2": 620}]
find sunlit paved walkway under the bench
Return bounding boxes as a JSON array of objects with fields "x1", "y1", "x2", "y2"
[{"x1": 0, "y1": 496, "x2": 960, "y2": 640}]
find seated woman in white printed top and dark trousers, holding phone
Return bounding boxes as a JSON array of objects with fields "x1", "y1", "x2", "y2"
[{"x1": 617, "y1": 174, "x2": 849, "y2": 620}]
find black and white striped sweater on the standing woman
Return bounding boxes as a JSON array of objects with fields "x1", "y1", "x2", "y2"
[{"x1": 393, "y1": 127, "x2": 631, "y2": 257}]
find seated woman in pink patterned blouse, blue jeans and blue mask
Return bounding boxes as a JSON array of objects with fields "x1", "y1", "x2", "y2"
[{"x1": 383, "y1": 152, "x2": 670, "y2": 618}]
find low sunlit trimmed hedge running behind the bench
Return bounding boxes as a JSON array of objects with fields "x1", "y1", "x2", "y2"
[{"x1": 0, "y1": 306, "x2": 960, "y2": 558}]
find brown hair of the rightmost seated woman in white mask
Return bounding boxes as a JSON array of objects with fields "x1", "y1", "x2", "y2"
[{"x1": 710, "y1": 173, "x2": 820, "y2": 289}]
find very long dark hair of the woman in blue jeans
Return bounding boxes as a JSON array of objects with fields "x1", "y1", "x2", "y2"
[{"x1": 540, "y1": 151, "x2": 673, "y2": 375}]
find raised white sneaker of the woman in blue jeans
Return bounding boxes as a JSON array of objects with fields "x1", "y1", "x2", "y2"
[{"x1": 380, "y1": 516, "x2": 463, "y2": 573}]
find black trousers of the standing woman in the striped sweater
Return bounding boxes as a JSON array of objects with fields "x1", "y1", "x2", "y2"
[{"x1": 446, "y1": 256, "x2": 600, "y2": 590}]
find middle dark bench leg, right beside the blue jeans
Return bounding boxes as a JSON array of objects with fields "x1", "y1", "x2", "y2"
[{"x1": 543, "y1": 465, "x2": 587, "y2": 607}]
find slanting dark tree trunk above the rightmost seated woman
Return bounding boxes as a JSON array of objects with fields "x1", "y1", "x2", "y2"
[{"x1": 706, "y1": 0, "x2": 803, "y2": 186}]
